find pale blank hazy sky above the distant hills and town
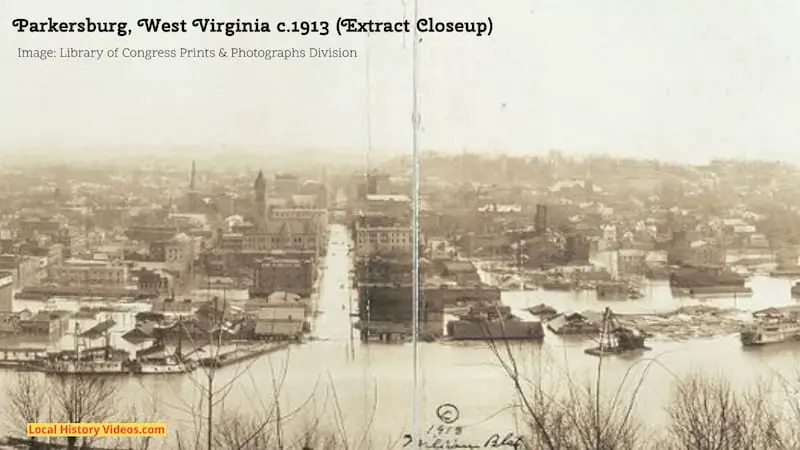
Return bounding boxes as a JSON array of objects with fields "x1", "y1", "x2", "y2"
[{"x1": 0, "y1": 0, "x2": 800, "y2": 160}]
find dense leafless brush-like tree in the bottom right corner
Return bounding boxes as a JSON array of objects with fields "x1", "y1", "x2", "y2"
[{"x1": 667, "y1": 374, "x2": 796, "y2": 450}]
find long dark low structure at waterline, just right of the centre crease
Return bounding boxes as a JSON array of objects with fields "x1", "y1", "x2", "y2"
[{"x1": 447, "y1": 305, "x2": 544, "y2": 340}]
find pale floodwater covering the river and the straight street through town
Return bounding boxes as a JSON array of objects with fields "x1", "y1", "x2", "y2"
[{"x1": 0, "y1": 225, "x2": 800, "y2": 448}]
